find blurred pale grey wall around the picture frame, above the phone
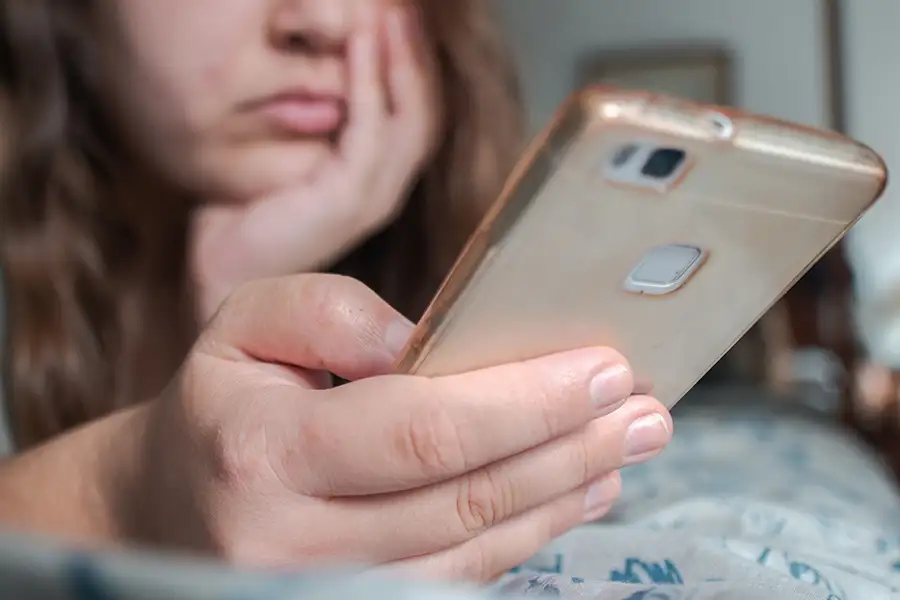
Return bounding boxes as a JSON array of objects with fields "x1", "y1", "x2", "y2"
[{"x1": 498, "y1": 0, "x2": 832, "y2": 131}]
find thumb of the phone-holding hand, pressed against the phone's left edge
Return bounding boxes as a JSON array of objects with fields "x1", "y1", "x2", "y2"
[{"x1": 199, "y1": 274, "x2": 413, "y2": 380}]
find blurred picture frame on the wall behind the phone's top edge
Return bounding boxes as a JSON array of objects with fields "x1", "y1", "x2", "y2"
[{"x1": 577, "y1": 45, "x2": 733, "y2": 106}]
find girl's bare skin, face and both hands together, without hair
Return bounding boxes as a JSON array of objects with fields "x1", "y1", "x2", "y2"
[{"x1": 0, "y1": 0, "x2": 672, "y2": 580}]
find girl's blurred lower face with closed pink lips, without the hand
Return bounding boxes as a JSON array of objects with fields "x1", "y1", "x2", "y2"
[{"x1": 100, "y1": 0, "x2": 414, "y2": 200}]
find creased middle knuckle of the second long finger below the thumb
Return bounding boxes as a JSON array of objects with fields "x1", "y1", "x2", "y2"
[{"x1": 456, "y1": 469, "x2": 513, "y2": 535}]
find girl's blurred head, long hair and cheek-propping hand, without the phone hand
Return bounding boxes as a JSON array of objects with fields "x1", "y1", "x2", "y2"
[{"x1": 0, "y1": 0, "x2": 520, "y2": 448}]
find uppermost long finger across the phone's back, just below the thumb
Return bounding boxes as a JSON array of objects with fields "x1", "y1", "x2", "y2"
[{"x1": 273, "y1": 348, "x2": 633, "y2": 498}]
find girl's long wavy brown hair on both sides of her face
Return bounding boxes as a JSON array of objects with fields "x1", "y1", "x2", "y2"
[{"x1": 0, "y1": 0, "x2": 521, "y2": 447}]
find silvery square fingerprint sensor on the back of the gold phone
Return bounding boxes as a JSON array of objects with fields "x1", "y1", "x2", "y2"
[{"x1": 625, "y1": 244, "x2": 705, "y2": 296}]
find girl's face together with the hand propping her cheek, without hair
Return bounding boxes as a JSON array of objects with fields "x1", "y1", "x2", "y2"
[{"x1": 96, "y1": 0, "x2": 440, "y2": 320}]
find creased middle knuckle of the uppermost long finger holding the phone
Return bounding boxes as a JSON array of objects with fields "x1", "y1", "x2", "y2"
[{"x1": 398, "y1": 402, "x2": 468, "y2": 476}]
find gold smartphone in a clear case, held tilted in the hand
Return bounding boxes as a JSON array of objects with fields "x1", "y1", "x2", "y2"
[{"x1": 397, "y1": 87, "x2": 887, "y2": 407}]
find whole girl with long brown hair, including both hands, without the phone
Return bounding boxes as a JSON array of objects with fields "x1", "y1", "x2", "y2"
[{"x1": 0, "y1": 0, "x2": 671, "y2": 579}]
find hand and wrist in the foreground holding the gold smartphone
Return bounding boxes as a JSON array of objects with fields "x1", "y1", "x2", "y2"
[{"x1": 0, "y1": 275, "x2": 672, "y2": 580}]
